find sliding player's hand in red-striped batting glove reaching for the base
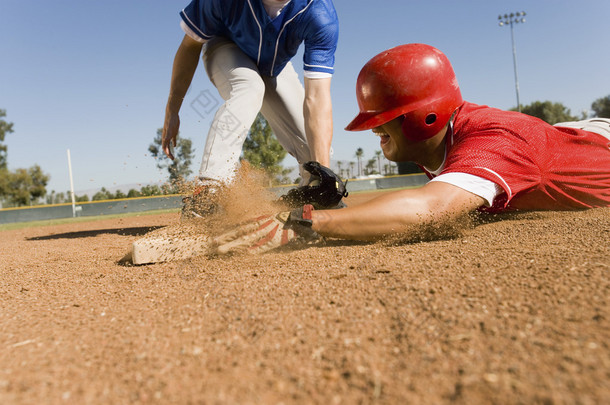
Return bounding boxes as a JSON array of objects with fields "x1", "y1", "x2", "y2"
[{"x1": 212, "y1": 205, "x2": 320, "y2": 254}]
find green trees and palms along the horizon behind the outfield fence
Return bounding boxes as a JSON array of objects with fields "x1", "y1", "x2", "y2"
[{"x1": 0, "y1": 95, "x2": 610, "y2": 207}]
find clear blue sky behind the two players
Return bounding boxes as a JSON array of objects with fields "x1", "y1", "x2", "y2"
[{"x1": 0, "y1": 0, "x2": 610, "y2": 194}]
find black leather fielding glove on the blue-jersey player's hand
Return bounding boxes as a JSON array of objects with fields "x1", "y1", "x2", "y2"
[{"x1": 280, "y1": 162, "x2": 347, "y2": 209}]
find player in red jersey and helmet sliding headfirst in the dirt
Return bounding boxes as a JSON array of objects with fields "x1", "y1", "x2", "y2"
[{"x1": 209, "y1": 44, "x2": 610, "y2": 253}]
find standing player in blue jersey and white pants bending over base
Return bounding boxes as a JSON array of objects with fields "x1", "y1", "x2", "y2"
[{"x1": 162, "y1": 0, "x2": 339, "y2": 216}]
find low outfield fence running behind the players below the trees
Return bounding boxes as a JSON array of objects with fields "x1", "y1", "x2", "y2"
[{"x1": 0, "y1": 173, "x2": 428, "y2": 224}]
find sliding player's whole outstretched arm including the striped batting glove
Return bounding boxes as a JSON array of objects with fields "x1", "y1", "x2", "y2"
[{"x1": 210, "y1": 182, "x2": 483, "y2": 254}]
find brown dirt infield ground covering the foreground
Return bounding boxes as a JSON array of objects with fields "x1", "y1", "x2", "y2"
[{"x1": 0, "y1": 190, "x2": 610, "y2": 404}]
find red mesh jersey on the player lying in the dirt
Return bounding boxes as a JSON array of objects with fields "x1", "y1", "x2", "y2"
[{"x1": 441, "y1": 102, "x2": 610, "y2": 212}]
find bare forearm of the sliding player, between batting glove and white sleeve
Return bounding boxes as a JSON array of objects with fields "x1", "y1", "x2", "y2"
[{"x1": 312, "y1": 182, "x2": 484, "y2": 240}]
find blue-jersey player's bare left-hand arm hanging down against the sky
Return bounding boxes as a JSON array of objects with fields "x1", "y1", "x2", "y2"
[{"x1": 161, "y1": 35, "x2": 203, "y2": 159}]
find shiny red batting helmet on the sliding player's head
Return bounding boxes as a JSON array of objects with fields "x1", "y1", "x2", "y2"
[{"x1": 345, "y1": 44, "x2": 463, "y2": 141}]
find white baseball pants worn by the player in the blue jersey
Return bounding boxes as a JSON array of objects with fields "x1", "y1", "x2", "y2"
[{"x1": 199, "y1": 38, "x2": 311, "y2": 183}]
